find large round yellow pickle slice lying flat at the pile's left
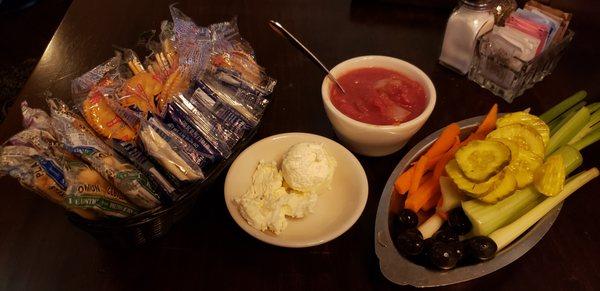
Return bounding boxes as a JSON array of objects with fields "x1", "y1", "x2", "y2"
[{"x1": 456, "y1": 140, "x2": 510, "y2": 182}]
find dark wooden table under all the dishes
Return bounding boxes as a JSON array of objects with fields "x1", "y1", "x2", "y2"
[{"x1": 0, "y1": 0, "x2": 600, "y2": 290}]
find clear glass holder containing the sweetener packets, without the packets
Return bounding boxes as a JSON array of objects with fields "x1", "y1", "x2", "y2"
[{"x1": 468, "y1": 30, "x2": 575, "y2": 103}]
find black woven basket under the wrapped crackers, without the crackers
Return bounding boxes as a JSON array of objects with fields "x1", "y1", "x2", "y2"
[{"x1": 67, "y1": 124, "x2": 260, "y2": 247}]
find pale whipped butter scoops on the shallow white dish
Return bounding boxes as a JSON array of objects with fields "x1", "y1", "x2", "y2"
[{"x1": 234, "y1": 143, "x2": 336, "y2": 234}]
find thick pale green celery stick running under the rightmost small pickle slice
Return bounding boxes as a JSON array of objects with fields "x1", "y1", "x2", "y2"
[{"x1": 462, "y1": 145, "x2": 583, "y2": 235}]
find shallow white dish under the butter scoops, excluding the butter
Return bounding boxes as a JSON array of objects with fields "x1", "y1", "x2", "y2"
[{"x1": 225, "y1": 133, "x2": 369, "y2": 248}]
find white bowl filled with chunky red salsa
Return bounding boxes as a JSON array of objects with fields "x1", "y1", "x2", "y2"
[{"x1": 321, "y1": 56, "x2": 436, "y2": 157}]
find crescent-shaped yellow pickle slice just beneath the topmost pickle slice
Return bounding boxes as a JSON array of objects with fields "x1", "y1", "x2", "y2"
[{"x1": 487, "y1": 124, "x2": 546, "y2": 157}]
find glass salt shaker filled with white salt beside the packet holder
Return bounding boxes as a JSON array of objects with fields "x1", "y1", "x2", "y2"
[{"x1": 439, "y1": 0, "x2": 497, "y2": 75}]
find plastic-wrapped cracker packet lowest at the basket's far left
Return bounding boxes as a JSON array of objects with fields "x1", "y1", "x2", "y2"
[{"x1": 0, "y1": 146, "x2": 139, "y2": 220}]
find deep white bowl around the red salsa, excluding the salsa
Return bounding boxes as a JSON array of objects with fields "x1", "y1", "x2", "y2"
[{"x1": 321, "y1": 56, "x2": 436, "y2": 157}]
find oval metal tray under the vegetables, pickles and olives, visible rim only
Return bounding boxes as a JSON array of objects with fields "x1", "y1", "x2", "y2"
[{"x1": 375, "y1": 116, "x2": 562, "y2": 287}]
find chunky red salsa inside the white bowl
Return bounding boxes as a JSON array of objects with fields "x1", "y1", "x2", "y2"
[{"x1": 330, "y1": 68, "x2": 427, "y2": 125}]
